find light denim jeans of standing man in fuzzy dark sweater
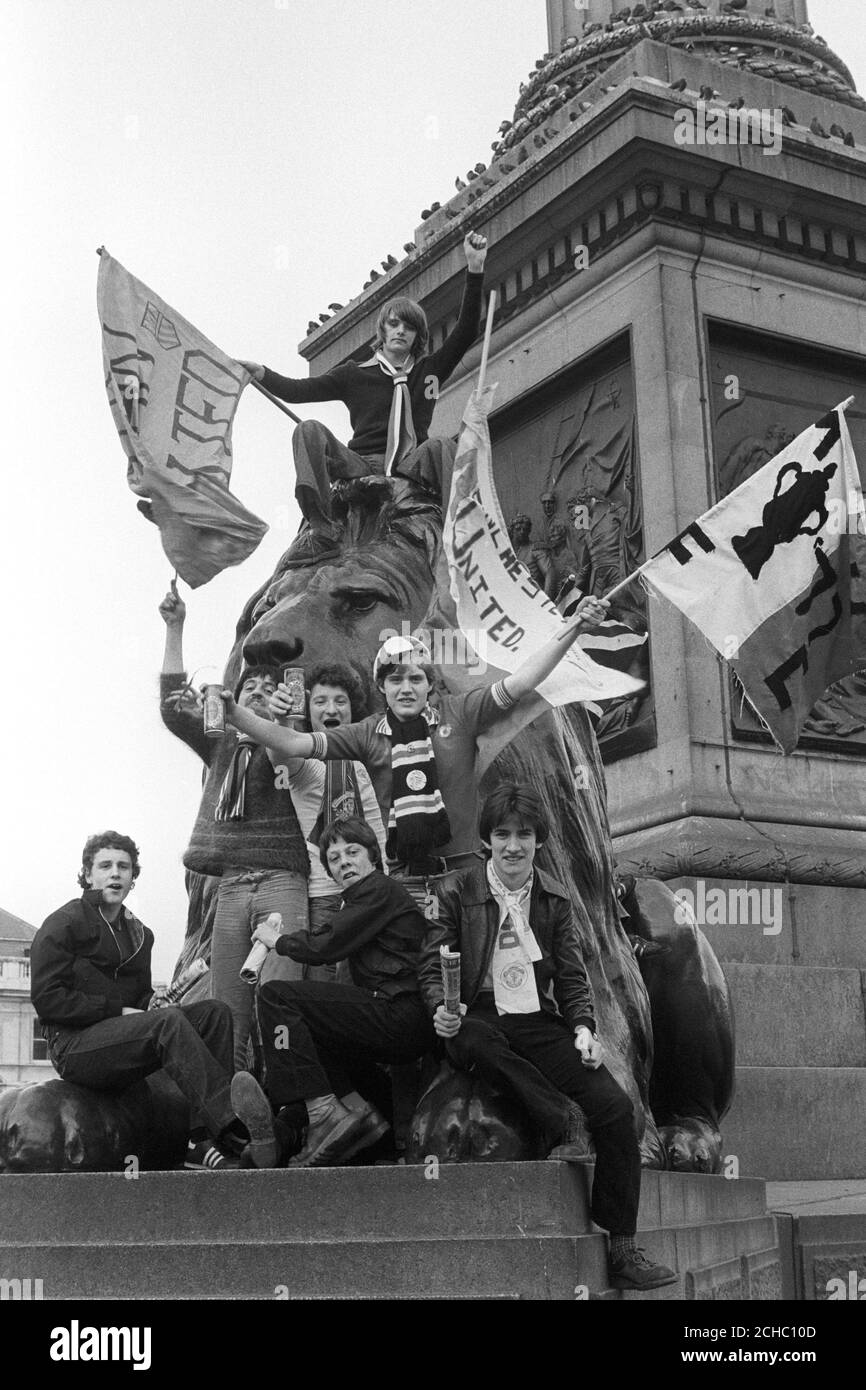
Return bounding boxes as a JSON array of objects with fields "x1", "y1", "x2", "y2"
[{"x1": 210, "y1": 869, "x2": 309, "y2": 1072}]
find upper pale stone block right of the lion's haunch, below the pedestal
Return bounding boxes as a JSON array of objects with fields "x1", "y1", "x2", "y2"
[{"x1": 723, "y1": 960, "x2": 866, "y2": 1068}]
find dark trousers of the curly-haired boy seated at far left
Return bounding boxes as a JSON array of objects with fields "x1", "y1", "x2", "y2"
[{"x1": 50, "y1": 999, "x2": 235, "y2": 1138}]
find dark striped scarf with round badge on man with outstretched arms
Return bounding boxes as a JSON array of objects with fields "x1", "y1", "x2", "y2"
[{"x1": 375, "y1": 705, "x2": 450, "y2": 862}]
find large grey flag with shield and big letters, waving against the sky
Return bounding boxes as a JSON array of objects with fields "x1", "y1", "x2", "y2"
[{"x1": 96, "y1": 247, "x2": 267, "y2": 588}]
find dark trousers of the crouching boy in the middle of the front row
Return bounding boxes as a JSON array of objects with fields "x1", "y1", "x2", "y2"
[{"x1": 254, "y1": 980, "x2": 434, "y2": 1108}]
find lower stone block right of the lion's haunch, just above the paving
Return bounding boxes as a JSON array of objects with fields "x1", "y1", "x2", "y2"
[{"x1": 721, "y1": 1067, "x2": 866, "y2": 1182}]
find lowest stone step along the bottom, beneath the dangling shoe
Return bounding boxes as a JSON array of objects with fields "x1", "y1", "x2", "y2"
[{"x1": 0, "y1": 1216, "x2": 774, "y2": 1301}]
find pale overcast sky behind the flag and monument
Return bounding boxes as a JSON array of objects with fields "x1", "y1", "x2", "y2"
[{"x1": 0, "y1": 0, "x2": 866, "y2": 977}]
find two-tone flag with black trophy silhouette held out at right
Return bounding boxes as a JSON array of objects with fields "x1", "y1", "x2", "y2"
[{"x1": 641, "y1": 402, "x2": 866, "y2": 753}]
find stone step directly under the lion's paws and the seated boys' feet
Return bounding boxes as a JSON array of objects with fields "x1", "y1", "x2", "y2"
[{"x1": 0, "y1": 1162, "x2": 766, "y2": 1245}]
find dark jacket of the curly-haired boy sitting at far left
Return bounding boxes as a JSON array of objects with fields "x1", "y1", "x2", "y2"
[{"x1": 31, "y1": 888, "x2": 153, "y2": 1029}]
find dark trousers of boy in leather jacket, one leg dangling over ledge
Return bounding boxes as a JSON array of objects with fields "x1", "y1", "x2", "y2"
[{"x1": 446, "y1": 999, "x2": 641, "y2": 1236}]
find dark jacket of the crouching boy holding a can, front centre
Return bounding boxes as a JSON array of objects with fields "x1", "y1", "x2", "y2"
[{"x1": 275, "y1": 869, "x2": 427, "y2": 999}]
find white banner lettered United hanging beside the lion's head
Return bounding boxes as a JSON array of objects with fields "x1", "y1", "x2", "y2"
[{"x1": 442, "y1": 386, "x2": 644, "y2": 705}]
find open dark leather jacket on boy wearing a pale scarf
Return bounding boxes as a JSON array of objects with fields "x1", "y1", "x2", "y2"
[{"x1": 418, "y1": 865, "x2": 595, "y2": 1031}]
